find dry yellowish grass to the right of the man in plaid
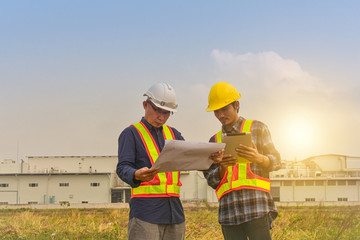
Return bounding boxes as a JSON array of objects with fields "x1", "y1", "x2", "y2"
[{"x1": 272, "y1": 205, "x2": 360, "y2": 240}]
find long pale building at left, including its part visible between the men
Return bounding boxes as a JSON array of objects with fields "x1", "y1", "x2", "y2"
[{"x1": 0, "y1": 156, "x2": 216, "y2": 204}]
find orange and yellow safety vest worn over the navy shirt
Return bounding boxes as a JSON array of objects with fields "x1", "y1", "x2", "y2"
[{"x1": 131, "y1": 122, "x2": 182, "y2": 198}]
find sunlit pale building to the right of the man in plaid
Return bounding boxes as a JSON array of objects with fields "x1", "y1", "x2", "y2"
[{"x1": 271, "y1": 154, "x2": 360, "y2": 202}]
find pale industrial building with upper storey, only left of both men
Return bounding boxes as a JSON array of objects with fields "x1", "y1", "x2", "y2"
[{"x1": 0, "y1": 157, "x2": 118, "y2": 204}]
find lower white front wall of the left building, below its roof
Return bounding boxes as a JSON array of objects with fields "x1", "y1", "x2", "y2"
[{"x1": 0, "y1": 174, "x2": 111, "y2": 204}]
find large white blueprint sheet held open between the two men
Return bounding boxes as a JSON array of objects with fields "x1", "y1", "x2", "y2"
[{"x1": 152, "y1": 140, "x2": 225, "y2": 172}]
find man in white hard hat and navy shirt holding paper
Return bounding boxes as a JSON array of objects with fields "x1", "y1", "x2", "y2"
[{"x1": 116, "y1": 83, "x2": 185, "y2": 240}]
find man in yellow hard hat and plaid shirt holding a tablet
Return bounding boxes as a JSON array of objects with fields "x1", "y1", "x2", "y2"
[{"x1": 204, "y1": 82, "x2": 281, "y2": 240}]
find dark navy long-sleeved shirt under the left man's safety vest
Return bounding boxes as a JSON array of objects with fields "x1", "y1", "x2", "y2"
[{"x1": 116, "y1": 118, "x2": 185, "y2": 224}]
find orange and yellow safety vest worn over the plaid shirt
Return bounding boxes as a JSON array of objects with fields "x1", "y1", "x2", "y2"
[{"x1": 215, "y1": 119, "x2": 270, "y2": 200}]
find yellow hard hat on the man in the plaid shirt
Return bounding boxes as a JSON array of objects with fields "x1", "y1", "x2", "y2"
[{"x1": 206, "y1": 82, "x2": 241, "y2": 112}]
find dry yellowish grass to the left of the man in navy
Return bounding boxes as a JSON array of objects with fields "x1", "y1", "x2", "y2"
[{"x1": 0, "y1": 209, "x2": 128, "y2": 239}]
